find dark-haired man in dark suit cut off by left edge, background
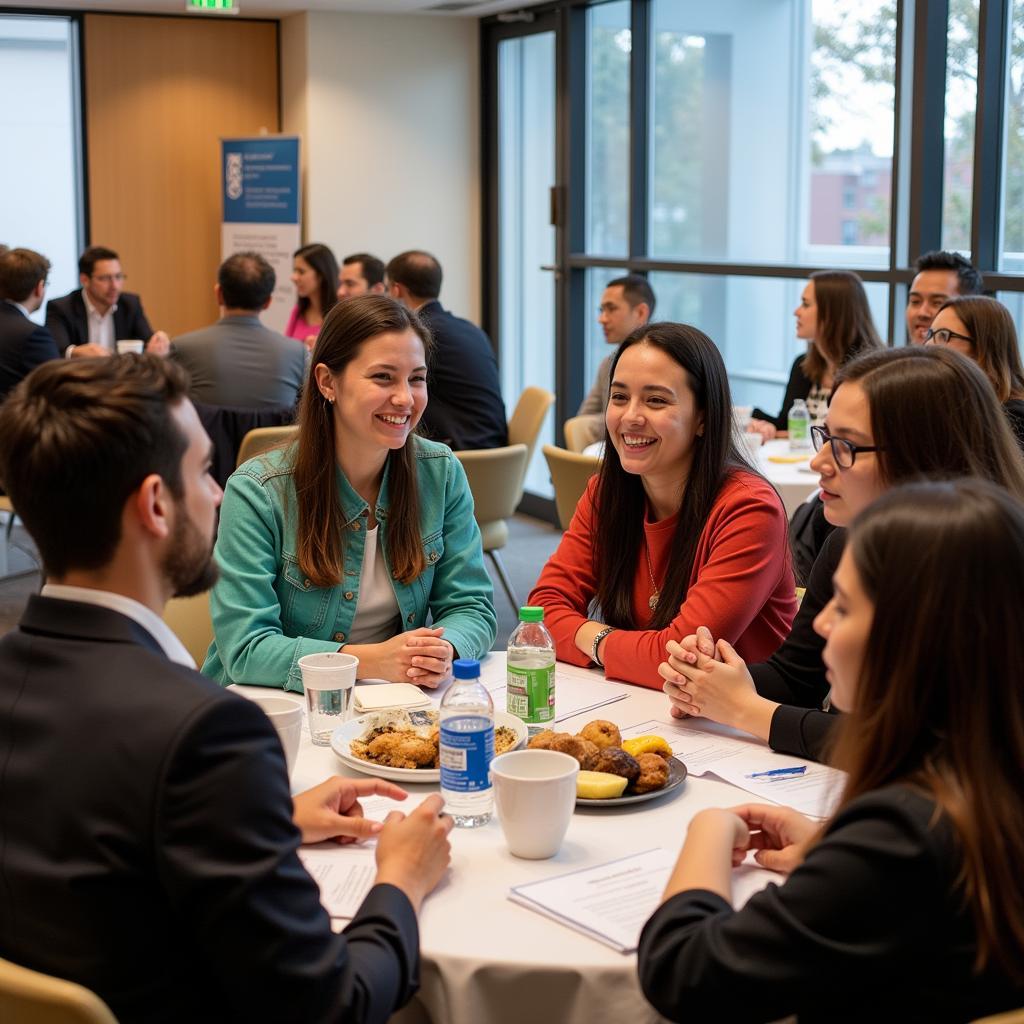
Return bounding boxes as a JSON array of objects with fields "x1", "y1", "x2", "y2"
[{"x1": 0, "y1": 249, "x2": 60, "y2": 401}]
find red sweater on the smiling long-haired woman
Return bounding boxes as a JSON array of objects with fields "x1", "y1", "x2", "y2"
[{"x1": 529, "y1": 470, "x2": 797, "y2": 689}]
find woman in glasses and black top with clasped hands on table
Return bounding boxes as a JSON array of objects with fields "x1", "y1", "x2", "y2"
[{"x1": 658, "y1": 346, "x2": 1024, "y2": 758}]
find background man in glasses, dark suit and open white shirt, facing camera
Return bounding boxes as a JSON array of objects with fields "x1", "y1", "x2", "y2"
[{"x1": 46, "y1": 246, "x2": 171, "y2": 355}]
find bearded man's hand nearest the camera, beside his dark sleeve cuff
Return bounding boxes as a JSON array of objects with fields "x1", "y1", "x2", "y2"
[{"x1": 375, "y1": 795, "x2": 454, "y2": 912}]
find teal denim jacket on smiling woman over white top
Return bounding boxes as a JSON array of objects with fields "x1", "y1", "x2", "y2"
[{"x1": 203, "y1": 437, "x2": 498, "y2": 692}]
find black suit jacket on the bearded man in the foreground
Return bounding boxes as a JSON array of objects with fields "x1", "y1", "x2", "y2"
[{"x1": 0, "y1": 596, "x2": 418, "y2": 1024}]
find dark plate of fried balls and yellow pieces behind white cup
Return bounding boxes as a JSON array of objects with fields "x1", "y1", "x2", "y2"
[{"x1": 527, "y1": 719, "x2": 686, "y2": 807}]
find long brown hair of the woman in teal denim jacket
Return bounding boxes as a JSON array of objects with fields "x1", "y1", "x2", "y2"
[{"x1": 294, "y1": 295, "x2": 431, "y2": 587}]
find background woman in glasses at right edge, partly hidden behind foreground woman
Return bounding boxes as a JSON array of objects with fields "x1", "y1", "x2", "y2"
[{"x1": 925, "y1": 295, "x2": 1024, "y2": 447}]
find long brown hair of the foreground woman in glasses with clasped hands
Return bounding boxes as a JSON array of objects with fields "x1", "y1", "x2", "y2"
[{"x1": 833, "y1": 345, "x2": 1024, "y2": 500}]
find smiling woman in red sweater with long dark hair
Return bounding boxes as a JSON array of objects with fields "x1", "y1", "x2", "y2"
[{"x1": 529, "y1": 324, "x2": 797, "y2": 689}]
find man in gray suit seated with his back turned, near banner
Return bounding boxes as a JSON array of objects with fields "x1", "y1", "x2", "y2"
[{"x1": 171, "y1": 252, "x2": 306, "y2": 409}]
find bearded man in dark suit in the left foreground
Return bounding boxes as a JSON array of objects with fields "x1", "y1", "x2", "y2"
[{"x1": 0, "y1": 355, "x2": 451, "y2": 1024}]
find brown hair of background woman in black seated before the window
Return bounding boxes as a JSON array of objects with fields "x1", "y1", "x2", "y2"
[{"x1": 803, "y1": 270, "x2": 882, "y2": 384}]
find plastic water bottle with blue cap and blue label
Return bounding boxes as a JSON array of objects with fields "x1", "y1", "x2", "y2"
[{"x1": 439, "y1": 658, "x2": 495, "y2": 828}]
